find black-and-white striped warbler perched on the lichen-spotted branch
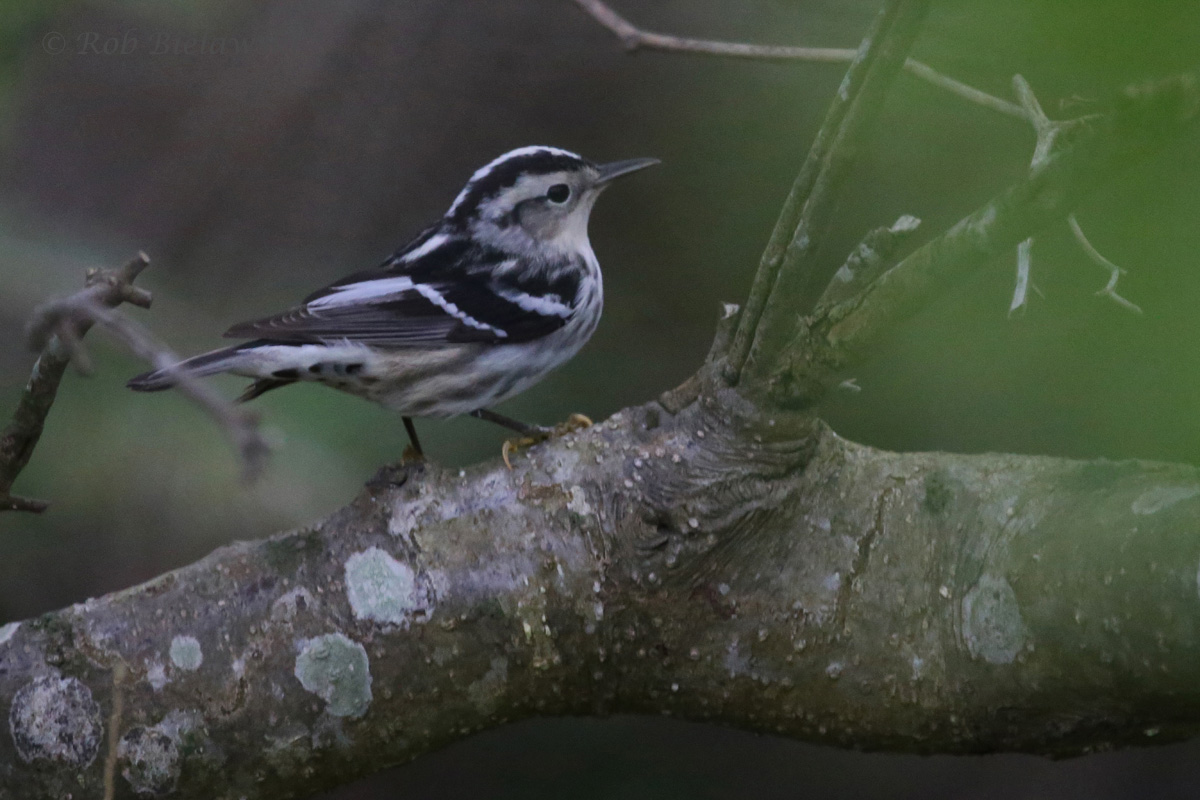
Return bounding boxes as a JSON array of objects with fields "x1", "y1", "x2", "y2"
[{"x1": 127, "y1": 145, "x2": 660, "y2": 460}]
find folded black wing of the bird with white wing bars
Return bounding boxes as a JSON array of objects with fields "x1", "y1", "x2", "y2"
[{"x1": 226, "y1": 231, "x2": 578, "y2": 347}]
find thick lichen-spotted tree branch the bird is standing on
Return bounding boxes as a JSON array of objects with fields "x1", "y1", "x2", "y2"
[{"x1": 11, "y1": 400, "x2": 1200, "y2": 800}]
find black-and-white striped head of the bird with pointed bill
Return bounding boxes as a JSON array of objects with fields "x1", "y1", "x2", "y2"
[{"x1": 446, "y1": 146, "x2": 659, "y2": 253}]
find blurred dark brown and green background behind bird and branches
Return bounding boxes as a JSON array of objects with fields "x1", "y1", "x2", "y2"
[{"x1": 0, "y1": 0, "x2": 1200, "y2": 800}]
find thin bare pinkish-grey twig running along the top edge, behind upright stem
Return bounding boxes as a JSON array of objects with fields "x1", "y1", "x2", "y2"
[{"x1": 575, "y1": 0, "x2": 1025, "y2": 119}]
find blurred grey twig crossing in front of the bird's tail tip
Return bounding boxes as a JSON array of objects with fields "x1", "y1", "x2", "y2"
[{"x1": 30, "y1": 293, "x2": 270, "y2": 481}]
